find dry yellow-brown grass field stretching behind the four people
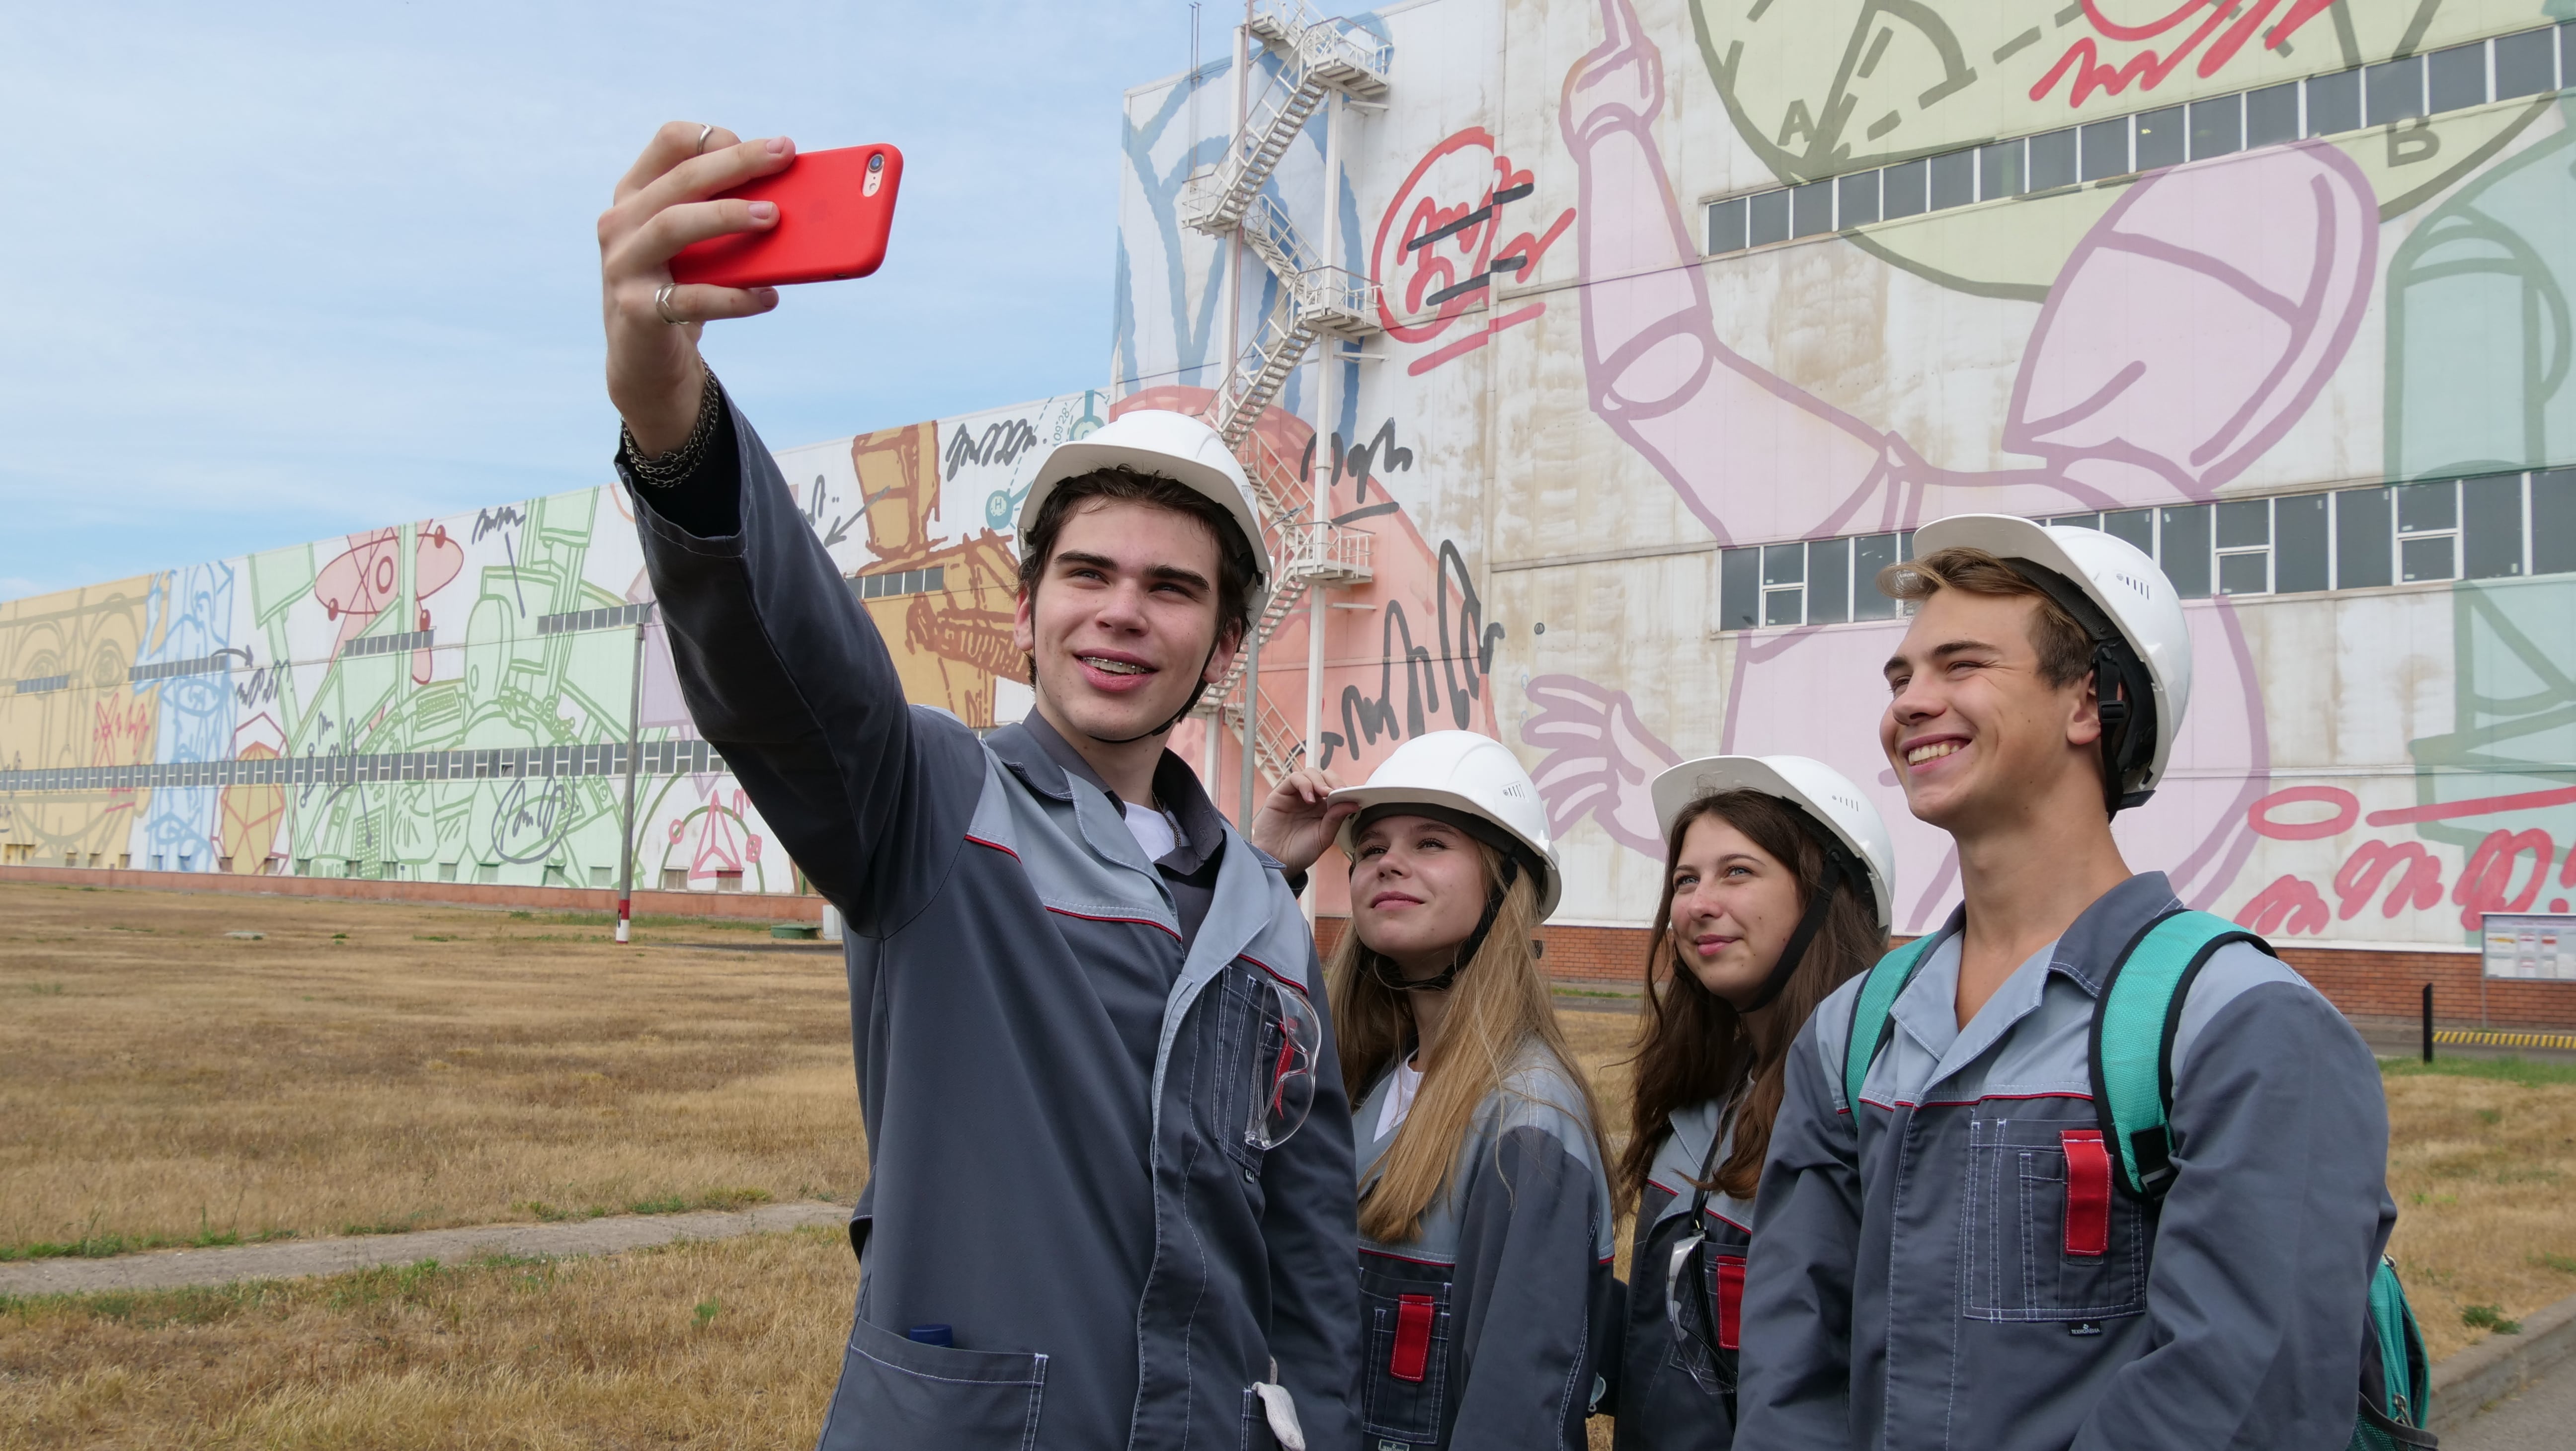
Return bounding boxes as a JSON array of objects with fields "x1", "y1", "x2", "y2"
[{"x1": 0, "y1": 887, "x2": 2576, "y2": 1451}]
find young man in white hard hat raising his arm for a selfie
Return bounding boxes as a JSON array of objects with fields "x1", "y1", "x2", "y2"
[{"x1": 600, "y1": 124, "x2": 1360, "y2": 1451}]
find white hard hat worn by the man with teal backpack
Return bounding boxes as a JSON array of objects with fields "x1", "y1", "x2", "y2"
[{"x1": 1914, "y1": 513, "x2": 2192, "y2": 806}]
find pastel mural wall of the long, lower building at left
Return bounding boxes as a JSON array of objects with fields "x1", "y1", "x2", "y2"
[{"x1": 0, "y1": 392, "x2": 1108, "y2": 892}]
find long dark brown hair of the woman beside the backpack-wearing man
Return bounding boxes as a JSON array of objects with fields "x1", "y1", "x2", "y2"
[{"x1": 1615, "y1": 791, "x2": 1888, "y2": 1204}]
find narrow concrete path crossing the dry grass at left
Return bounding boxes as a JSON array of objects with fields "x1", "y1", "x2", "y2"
[{"x1": 0, "y1": 1201, "x2": 850, "y2": 1294}]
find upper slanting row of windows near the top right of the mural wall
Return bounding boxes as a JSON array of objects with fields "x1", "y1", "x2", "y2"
[{"x1": 1708, "y1": 23, "x2": 2576, "y2": 255}]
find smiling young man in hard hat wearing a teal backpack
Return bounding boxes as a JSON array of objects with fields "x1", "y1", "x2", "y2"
[{"x1": 1736, "y1": 515, "x2": 2424, "y2": 1451}]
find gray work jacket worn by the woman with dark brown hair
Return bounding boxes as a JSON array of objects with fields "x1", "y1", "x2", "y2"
[{"x1": 1610, "y1": 1098, "x2": 1754, "y2": 1451}]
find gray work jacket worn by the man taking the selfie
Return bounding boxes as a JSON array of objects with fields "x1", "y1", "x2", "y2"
[{"x1": 634, "y1": 392, "x2": 1358, "y2": 1451}]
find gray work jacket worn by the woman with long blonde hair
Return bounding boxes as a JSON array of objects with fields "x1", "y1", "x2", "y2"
[{"x1": 1350, "y1": 1044, "x2": 1618, "y2": 1451}]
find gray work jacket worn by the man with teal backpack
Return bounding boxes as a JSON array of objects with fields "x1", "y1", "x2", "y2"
[{"x1": 1739, "y1": 871, "x2": 2396, "y2": 1451}]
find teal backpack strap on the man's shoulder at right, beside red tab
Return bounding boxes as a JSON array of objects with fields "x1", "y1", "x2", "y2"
[{"x1": 2089, "y1": 910, "x2": 2277, "y2": 1199}]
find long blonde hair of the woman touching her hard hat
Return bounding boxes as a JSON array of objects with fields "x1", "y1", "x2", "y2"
[{"x1": 1324, "y1": 843, "x2": 1602, "y2": 1245}]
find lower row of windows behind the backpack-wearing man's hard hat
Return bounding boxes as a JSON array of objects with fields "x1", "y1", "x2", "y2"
[{"x1": 1718, "y1": 469, "x2": 2576, "y2": 629}]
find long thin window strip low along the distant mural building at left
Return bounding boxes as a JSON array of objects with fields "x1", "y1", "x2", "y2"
[{"x1": 0, "y1": 740, "x2": 724, "y2": 791}]
